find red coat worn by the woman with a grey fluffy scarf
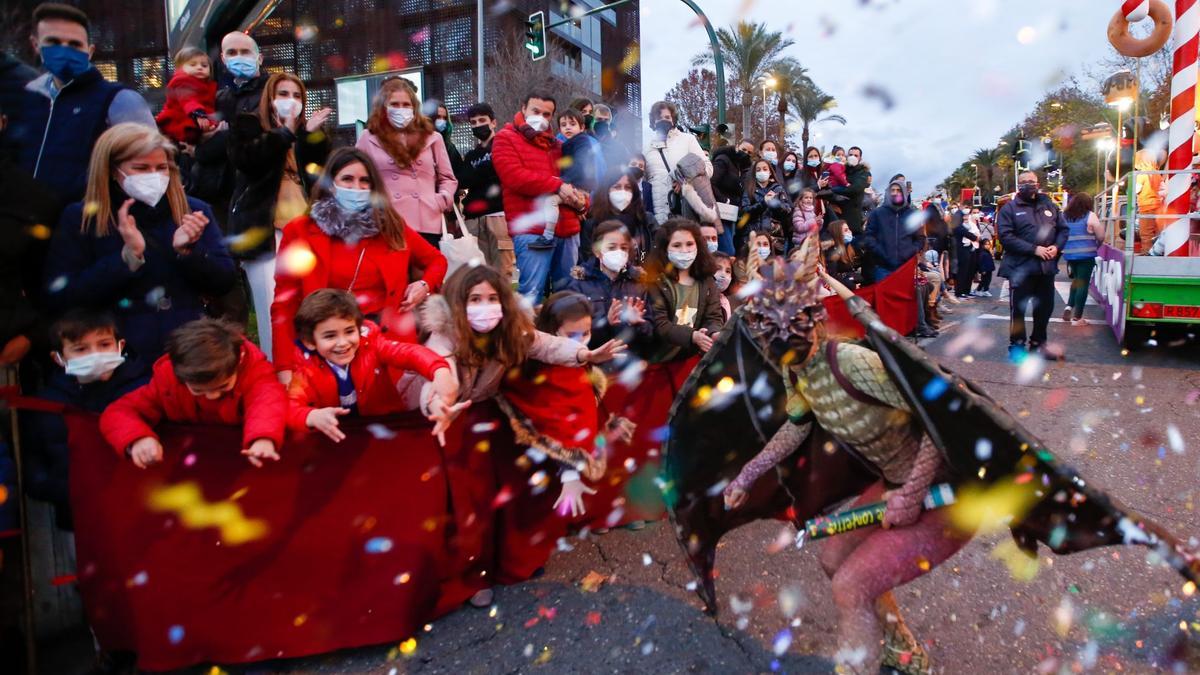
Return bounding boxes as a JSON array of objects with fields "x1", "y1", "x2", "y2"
[{"x1": 271, "y1": 215, "x2": 446, "y2": 370}]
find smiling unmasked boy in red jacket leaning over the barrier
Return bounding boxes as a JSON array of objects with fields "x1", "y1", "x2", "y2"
[{"x1": 288, "y1": 288, "x2": 458, "y2": 443}]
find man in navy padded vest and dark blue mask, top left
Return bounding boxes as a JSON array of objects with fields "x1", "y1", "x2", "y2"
[{"x1": 7, "y1": 2, "x2": 157, "y2": 204}]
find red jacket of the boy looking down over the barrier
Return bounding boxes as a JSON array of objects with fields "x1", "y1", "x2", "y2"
[{"x1": 100, "y1": 340, "x2": 288, "y2": 455}]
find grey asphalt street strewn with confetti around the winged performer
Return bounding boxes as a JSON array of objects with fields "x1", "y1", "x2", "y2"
[{"x1": 60, "y1": 279, "x2": 1200, "y2": 675}]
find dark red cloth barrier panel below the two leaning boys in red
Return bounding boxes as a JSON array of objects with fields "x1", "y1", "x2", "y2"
[{"x1": 66, "y1": 413, "x2": 482, "y2": 670}]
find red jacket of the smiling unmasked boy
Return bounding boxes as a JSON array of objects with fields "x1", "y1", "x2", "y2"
[{"x1": 288, "y1": 322, "x2": 450, "y2": 432}]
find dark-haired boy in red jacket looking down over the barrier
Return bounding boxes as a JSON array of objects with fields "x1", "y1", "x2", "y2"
[{"x1": 100, "y1": 318, "x2": 288, "y2": 468}]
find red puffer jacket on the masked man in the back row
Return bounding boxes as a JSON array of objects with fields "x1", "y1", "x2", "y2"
[{"x1": 492, "y1": 113, "x2": 580, "y2": 237}]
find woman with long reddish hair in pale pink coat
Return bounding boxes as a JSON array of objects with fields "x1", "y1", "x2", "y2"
[{"x1": 356, "y1": 77, "x2": 458, "y2": 246}]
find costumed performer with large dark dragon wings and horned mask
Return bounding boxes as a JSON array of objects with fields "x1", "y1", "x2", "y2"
[{"x1": 661, "y1": 229, "x2": 1200, "y2": 674}]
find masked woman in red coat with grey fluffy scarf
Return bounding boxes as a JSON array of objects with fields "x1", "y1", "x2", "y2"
[{"x1": 271, "y1": 148, "x2": 446, "y2": 383}]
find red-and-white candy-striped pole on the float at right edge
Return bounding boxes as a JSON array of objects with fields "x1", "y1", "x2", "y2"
[{"x1": 1166, "y1": 0, "x2": 1200, "y2": 256}]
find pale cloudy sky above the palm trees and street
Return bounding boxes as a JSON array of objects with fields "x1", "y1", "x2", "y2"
[{"x1": 641, "y1": 0, "x2": 1120, "y2": 195}]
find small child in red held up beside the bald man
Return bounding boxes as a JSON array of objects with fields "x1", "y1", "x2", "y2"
[{"x1": 155, "y1": 47, "x2": 217, "y2": 145}]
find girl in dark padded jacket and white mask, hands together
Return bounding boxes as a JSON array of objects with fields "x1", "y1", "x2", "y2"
[{"x1": 563, "y1": 220, "x2": 653, "y2": 358}]
